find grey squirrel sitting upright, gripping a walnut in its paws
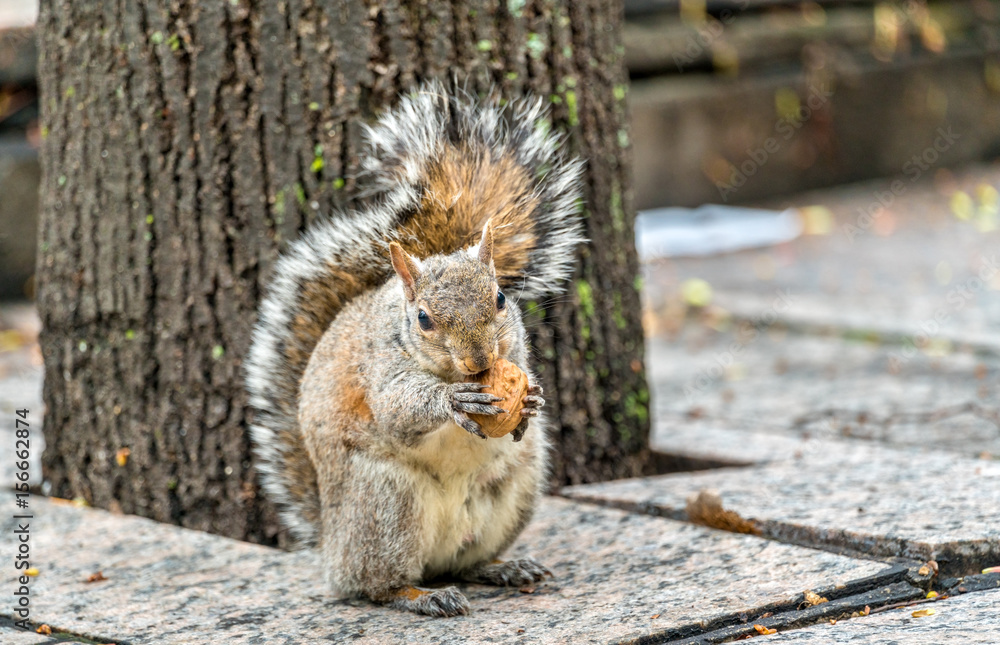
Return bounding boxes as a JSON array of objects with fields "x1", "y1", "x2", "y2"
[{"x1": 246, "y1": 84, "x2": 584, "y2": 616}]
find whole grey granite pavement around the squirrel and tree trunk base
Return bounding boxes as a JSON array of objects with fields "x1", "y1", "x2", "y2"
[{"x1": 0, "y1": 167, "x2": 1000, "y2": 645}]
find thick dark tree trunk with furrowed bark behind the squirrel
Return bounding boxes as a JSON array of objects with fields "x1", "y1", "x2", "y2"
[{"x1": 38, "y1": 0, "x2": 648, "y2": 542}]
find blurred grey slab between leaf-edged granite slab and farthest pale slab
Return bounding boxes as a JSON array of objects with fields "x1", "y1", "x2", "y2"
[{"x1": 646, "y1": 322, "x2": 1000, "y2": 461}]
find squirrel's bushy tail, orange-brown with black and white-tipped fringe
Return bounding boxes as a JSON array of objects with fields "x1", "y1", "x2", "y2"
[{"x1": 247, "y1": 84, "x2": 583, "y2": 545}]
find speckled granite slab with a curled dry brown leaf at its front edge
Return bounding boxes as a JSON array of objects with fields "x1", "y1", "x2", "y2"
[{"x1": 563, "y1": 441, "x2": 1000, "y2": 575}]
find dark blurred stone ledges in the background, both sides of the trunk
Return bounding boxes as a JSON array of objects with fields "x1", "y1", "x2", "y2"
[{"x1": 0, "y1": 0, "x2": 1000, "y2": 300}]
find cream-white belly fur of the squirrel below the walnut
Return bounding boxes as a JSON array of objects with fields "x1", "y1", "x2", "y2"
[{"x1": 404, "y1": 423, "x2": 537, "y2": 576}]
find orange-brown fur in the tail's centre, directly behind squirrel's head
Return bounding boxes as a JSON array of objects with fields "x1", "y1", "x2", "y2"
[{"x1": 399, "y1": 146, "x2": 538, "y2": 276}]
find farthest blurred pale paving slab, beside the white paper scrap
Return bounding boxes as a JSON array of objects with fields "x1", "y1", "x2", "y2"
[{"x1": 644, "y1": 164, "x2": 1000, "y2": 354}]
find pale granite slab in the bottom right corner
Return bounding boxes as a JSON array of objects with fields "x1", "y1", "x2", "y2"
[{"x1": 767, "y1": 590, "x2": 1000, "y2": 645}]
